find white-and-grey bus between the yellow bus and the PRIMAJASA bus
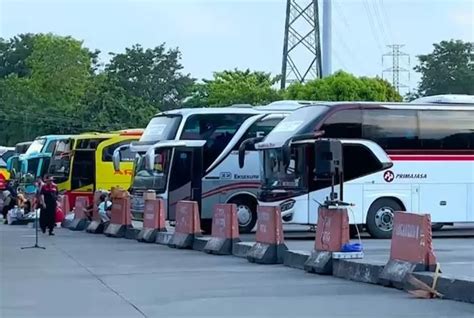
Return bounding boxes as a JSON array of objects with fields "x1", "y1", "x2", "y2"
[{"x1": 114, "y1": 102, "x2": 301, "y2": 232}]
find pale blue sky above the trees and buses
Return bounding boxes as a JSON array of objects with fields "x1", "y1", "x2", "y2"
[{"x1": 0, "y1": 0, "x2": 474, "y2": 93}]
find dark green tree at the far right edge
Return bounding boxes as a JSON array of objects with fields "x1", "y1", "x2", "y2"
[{"x1": 414, "y1": 40, "x2": 474, "y2": 96}]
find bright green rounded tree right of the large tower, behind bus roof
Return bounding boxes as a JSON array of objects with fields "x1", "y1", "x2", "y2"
[{"x1": 284, "y1": 71, "x2": 402, "y2": 101}]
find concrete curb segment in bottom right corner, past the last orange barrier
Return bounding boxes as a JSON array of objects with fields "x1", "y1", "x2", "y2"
[{"x1": 413, "y1": 272, "x2": 474, "y2": 304}]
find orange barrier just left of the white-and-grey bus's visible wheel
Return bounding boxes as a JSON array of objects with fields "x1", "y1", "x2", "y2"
[{"x1": 203, "y1": 204, "x2": 240, "y2": 255}]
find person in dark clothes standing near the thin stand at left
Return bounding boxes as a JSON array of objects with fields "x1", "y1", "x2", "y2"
[{"x1": 40, "y1": 175, "x2": 58, "y2": 235}]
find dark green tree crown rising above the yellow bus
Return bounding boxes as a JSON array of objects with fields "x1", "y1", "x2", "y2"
[{"x1": 105, "y1": 43, "x2": 194, "y2": 110}]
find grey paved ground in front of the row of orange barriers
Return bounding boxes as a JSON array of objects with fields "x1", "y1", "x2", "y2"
[{"x1": 0, "y1": 225, "x2": 474, "y2": 318}]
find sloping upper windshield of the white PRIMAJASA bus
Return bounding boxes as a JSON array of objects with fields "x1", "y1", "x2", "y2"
[{"x1": 263, "y1": 105, "x2": 329, "y2": 147}]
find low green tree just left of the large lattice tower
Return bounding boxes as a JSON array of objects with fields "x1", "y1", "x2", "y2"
[{"x1": 186, "y1": 69, "x2": 281, "y2": 107}]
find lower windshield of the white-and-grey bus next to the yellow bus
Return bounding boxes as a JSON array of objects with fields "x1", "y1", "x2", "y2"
[{"x1": 133, "y1": 149, "x2": 170, "y2": 193}]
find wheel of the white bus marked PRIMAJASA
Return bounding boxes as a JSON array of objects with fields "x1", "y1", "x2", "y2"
[{"x1": 367, "y1": 198, "x2": 405, "y2": 239}]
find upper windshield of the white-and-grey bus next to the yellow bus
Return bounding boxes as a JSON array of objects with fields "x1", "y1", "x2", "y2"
[{"x1": 140, "y1": 115, "x2": 181, "y2": 142}]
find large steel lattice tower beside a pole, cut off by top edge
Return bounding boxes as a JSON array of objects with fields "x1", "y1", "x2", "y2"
[{"x1": 281, "y1": 0, "x2": 321, "y2": 88}]
